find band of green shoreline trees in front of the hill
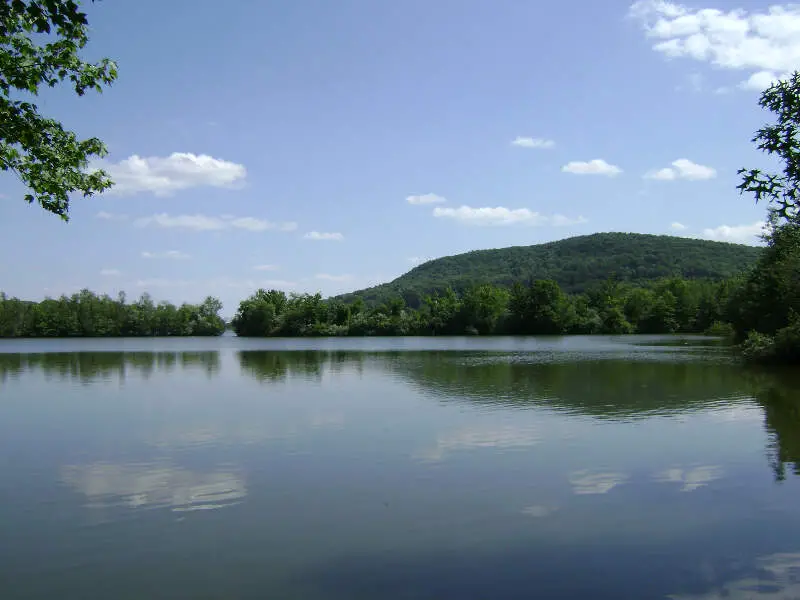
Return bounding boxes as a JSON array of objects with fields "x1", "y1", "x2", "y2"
[{"x1": 233, "y1": 278, "x2": 744, "y2": 336}]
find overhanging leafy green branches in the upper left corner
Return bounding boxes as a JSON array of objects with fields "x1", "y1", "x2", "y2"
[{"x1": 0, "y1": 0, "x2": 117, "y2": 220}]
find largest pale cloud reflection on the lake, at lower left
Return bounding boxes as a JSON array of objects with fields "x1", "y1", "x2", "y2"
[{"x1": 61, "y1": 462, "x2": 247, "y2": 512}]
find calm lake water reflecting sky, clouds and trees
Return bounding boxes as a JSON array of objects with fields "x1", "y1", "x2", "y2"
[{"x1": 0, "y1": 337, "x2": 800, "y2": 600}]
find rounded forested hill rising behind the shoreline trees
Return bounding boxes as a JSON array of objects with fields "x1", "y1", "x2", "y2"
[{"x1": 339, "y1": 233, "x2": 761, "y2": 306}]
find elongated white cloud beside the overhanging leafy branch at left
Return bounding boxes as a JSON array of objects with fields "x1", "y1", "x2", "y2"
[{"x1": 99, "y1": 152, "x2": 247, "y2": 196}]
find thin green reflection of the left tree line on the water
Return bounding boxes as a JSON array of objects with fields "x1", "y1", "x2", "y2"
[{"x1": 0, "y1": 351, "x2": 220, "y2": 383}]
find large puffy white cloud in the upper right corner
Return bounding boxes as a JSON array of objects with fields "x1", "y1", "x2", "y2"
[{"x1": 630, "y1": 0, "x2": 800, "y2": 90}]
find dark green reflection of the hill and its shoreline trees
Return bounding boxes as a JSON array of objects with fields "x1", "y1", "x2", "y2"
[{"x1": 238, "y1": 351, "x2": 751, "y2": 419}]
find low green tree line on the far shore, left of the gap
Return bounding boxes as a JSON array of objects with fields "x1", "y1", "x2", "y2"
[{"x1": 0, "y1": 290, "x2": 225, "y2": 338}]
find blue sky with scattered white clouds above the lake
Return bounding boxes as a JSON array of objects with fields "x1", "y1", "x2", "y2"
[{"x1": 0, "y1": 0, "x2": 800, "y2": 315}]
